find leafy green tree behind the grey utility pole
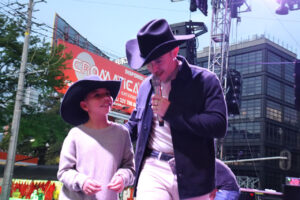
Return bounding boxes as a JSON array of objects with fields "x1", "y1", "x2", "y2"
[{"x1": 0, "y1": 14, "x2": 71, "y2": 164}]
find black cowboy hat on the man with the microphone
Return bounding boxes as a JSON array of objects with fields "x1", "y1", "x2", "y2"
[{"x1": 126, "y1": 19, "x2": 195, "y2": 69}]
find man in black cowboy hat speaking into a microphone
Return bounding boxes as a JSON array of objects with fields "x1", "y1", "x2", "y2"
[{"x1": 126, "y1": 19, "x2": 227, "y2": 200}]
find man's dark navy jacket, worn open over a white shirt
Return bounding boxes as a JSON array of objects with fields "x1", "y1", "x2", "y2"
[{"x1": 125, "y1": 56, "x2": 227, "y2": 199}]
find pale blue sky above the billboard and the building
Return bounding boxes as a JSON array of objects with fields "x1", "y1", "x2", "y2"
[{"x1": 17, "y1": 0, "x2": 300, "y2": 58}]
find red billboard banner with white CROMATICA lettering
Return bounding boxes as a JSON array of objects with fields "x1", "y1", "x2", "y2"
[{"x1": 58, "y1": 40, "x2": 146, "y2": 114}]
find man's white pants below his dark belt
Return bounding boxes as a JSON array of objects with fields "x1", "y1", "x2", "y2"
[{"x1": 136, "y1": 157, "x2": 209, "y2": 200}]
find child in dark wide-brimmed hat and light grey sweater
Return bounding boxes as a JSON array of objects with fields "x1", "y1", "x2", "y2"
[{"x1": 57, "y1": 76, "x2": 134, "y2": 200}]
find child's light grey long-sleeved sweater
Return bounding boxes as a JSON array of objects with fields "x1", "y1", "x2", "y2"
[{"x1": 57, "y1": 123, "x2": 135, "y2": 200}]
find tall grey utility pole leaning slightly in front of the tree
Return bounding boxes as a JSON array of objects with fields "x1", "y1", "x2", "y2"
[{"x1": 1, "y1": 0, "x2": 33, "y2": 200}]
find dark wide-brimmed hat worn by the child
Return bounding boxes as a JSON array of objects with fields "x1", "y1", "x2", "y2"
[{"x1": 60, "y1": 75, "x2": 121, "y2": 126}]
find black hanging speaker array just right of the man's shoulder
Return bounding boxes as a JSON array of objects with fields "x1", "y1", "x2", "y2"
[{"x1": 226, "y1": 69, "x2": 242, "y2": 115}]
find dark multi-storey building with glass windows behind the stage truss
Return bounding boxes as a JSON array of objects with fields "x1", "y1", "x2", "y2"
[{"x1": 201, "y1": 38, "x2": 300, "y2": 191}]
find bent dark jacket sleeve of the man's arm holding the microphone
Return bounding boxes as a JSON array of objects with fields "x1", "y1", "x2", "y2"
[{"x1": 164, "y1": 73, "x2": 227, "y2": 138}]
